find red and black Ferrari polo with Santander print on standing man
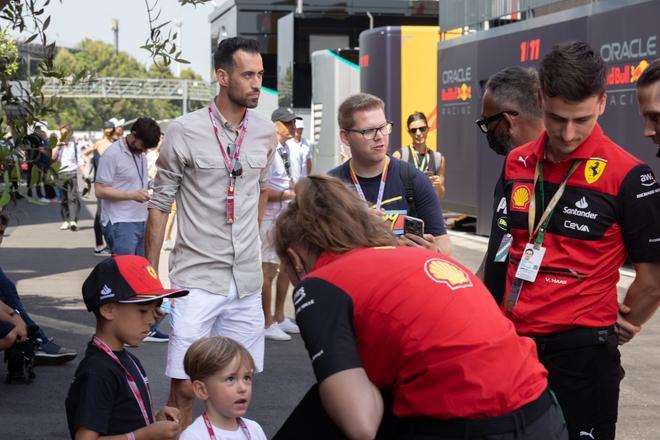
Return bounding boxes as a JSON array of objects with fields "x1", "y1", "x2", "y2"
[{"x1": 504, "y1": 125, "x2": 660, "y2": 335}]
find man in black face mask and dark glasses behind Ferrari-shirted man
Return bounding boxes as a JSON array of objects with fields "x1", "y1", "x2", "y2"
[{"x1": 476, "y1": 66, "x2": 544, "y2": 304}]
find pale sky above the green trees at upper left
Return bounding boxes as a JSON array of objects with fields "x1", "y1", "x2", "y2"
[{"x1": 47, "y1": 0, "x2": 217, "y2": 79}]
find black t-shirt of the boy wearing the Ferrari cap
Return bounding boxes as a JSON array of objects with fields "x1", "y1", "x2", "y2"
[{"x1": 65, "y1": 342, "x2": 154, "y2": 438}]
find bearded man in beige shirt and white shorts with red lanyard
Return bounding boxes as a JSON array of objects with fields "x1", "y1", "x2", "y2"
[{"x1": 146, "y1": 37, "x2": 277, "y2": 427}]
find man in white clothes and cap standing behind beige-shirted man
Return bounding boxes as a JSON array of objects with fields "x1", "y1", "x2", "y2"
[{"x1": 259, "y1": 107, "x2": 300, "y2": 341}]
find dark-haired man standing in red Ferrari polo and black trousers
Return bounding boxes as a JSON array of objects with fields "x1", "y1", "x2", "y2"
[{"x1": 502, "y1": 42, "x2": 660, "y2": 440}]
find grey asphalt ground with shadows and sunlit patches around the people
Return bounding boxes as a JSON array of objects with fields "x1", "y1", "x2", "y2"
[{"x1": 0, "y1": 199, "x2": 660, "y2": 440}]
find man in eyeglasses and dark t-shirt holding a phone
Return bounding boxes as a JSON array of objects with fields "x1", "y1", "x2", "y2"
[{"x1": 329, "y1": 93, "x2": 451, "y2": 255}]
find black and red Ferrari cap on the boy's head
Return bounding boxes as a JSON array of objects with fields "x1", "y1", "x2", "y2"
[{"x1": 82, "y1": 255, "x2": 188, "y2": 312}]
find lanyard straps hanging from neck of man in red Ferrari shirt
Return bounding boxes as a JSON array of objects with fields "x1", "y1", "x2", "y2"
[{"x1": 504, "y1": 159, "x2": 582, "y2": 312}]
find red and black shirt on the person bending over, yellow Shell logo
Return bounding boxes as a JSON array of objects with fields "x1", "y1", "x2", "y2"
[{"x1": 293, "y1": 247, "x2": 547, "y2": 419}]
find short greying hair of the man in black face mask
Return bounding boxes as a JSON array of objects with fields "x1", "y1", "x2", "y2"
[{"x1": 484, "y1": 66, "x2": 542, "y2": 119}]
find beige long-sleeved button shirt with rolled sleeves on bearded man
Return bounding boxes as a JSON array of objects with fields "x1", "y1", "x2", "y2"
[{"x1": 149, "y1": 96, "x2": 277, "y2": 297}]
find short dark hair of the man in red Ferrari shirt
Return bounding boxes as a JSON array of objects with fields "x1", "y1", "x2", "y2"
[{"x1": 539, "y1": 41, "x2": 607, "y2": 102}]
